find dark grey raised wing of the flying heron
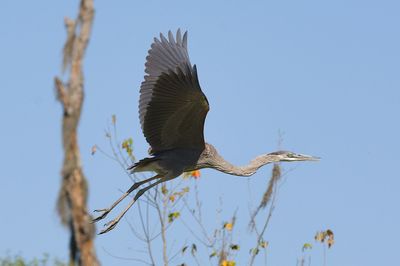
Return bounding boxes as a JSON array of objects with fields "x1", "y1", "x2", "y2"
[{"x1": 139, "y1": 30, "x2": 209, "y2": 153}]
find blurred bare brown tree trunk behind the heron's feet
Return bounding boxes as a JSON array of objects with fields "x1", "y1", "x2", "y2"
[{"x1": 55, "y1": 0, "x2": 99, "y2": 266}]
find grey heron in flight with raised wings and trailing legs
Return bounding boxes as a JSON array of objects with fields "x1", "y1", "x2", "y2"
[{"x1": 93, "y1": 30, "x2": 319, "y2": 234}]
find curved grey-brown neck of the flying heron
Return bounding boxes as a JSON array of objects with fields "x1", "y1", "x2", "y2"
[{"x1": 206, "y1": 154, "x2": 279, "y2": 176}]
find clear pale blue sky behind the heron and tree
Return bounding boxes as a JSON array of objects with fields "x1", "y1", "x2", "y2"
[{"x1": 0, "y1": 0, "x2": 400, "y2": 266}]
